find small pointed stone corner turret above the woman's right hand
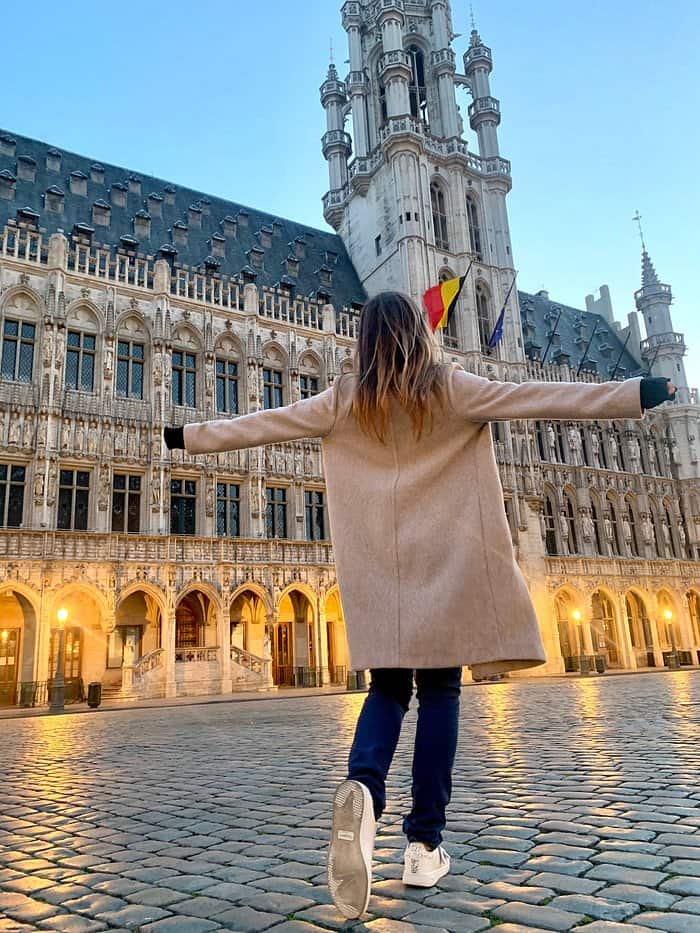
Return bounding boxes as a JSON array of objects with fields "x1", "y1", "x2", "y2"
[{"x1": 634, "y1": 245, "x2": 690, "y2": 404}]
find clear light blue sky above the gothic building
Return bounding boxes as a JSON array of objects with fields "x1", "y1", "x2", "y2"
[{"x1": 5, "y1": 0, "x2": 700, "y2": 387}]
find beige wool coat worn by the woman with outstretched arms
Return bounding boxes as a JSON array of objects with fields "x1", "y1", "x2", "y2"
[{"x1": 184, "y1": 363, "x2": 643, "y2": 676}]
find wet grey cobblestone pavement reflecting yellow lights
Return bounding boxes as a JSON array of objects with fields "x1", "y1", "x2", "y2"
[{"x1": 0, "y1": 672, "x2": 700, "y2": 933}]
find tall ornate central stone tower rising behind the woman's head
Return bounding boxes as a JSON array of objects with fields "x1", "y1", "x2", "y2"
[{"x1": 321, "y1": 0, "x2": 524, "y2": 360}]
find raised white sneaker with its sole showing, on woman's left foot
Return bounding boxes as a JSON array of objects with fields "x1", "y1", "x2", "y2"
[{"x1": 328, "y1": 781, "x2": 377, "y2": 920}]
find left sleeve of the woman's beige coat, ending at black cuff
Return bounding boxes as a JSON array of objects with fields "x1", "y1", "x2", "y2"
[{"x1": 184, "y1": 385, "x2": 336, "y2": 454}]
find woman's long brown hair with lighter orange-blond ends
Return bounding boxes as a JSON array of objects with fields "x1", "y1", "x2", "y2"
[{"x1": 352, "y1": 292, "x2": 446, "y2": 444}]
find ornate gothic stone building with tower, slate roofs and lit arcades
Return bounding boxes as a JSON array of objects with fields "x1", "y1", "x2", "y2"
[{"x1": 0, "y1": 0, "x2": 700, "y2": 703}]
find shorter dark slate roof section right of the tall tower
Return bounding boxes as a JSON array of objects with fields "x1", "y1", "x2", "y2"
[{"x1": 518, "y1": 291, "x2": 646, "y2": 379}]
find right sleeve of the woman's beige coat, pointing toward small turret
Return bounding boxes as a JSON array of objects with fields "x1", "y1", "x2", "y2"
[{"x1": 450, "y1": 367, "x2": 644, "y2": 421}]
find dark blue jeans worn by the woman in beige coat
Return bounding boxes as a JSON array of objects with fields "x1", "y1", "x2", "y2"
[{"x1": 348, "y1": 667, "x2": 462, "y2": 849}]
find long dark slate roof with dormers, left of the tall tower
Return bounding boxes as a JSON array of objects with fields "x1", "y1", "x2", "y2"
[{"x1": 0, "y1": 129, "x2": 367, "y2": 307}]
